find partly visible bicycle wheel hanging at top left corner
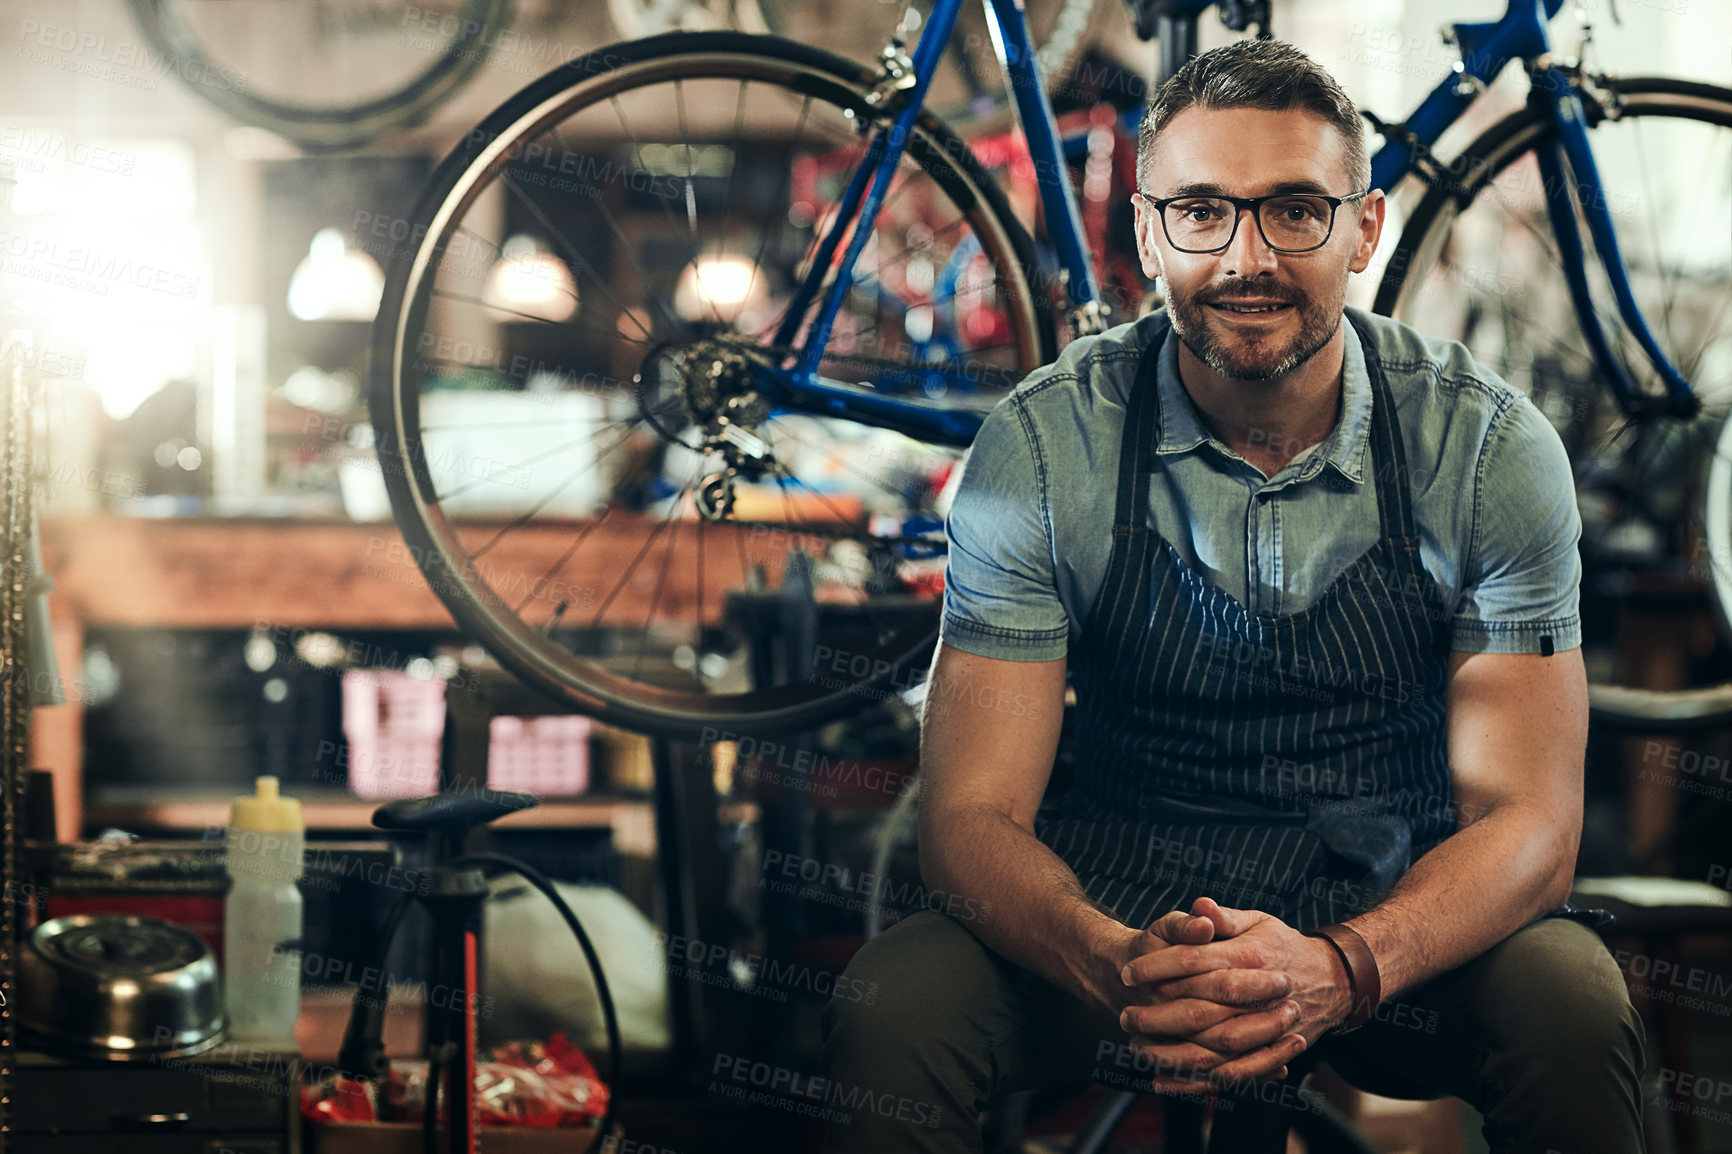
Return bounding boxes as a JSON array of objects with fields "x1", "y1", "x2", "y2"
[{"x1": 130, "y1": 0, "x2": 511, "y2": 149}]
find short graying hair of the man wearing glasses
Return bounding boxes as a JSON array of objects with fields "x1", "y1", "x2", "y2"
[{"x1": 1136, "y1": 40, "x2": 1372, "y2": 192}]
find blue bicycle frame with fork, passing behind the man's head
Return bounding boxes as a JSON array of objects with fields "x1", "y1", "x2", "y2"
[{"x1": 760, "y1": 0, "x2": 1701, "y2": 445}]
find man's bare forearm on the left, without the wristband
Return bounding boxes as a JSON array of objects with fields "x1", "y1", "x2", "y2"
[{"x1": 920, "y1": 806, "x2": 1134, "y2": 1012}]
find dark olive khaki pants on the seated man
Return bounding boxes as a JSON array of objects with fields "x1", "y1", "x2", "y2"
[{"x1": 823, "y1": 911, "x2": 1644, "y2": 1154}]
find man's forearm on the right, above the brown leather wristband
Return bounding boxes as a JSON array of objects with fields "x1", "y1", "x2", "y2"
[{"x1": 1346, "y1": 806, "x2": 1576, "y2": 998}]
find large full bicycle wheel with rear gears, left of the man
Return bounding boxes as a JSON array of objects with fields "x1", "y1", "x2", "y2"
[{"x1": 369, "y1": 31, "x2": 1053, "y2": 736}]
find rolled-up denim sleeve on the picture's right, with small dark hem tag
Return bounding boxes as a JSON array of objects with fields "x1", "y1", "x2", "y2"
[{"x1": 1453, "y1": 397, "x2": 1581, "y2": 653}]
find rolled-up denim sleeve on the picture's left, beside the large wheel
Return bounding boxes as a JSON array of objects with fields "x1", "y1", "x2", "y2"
[{"x1": 939, "y1": 400, "x2": 1070, "y2": 662}]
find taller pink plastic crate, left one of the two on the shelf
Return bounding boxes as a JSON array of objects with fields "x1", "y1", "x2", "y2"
[{"x1": 343, "y1": 669, "x2": 445, "y2": 797}]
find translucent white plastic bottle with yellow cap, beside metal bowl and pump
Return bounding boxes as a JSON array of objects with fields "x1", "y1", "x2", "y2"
[{"x1": 222, "y1": 776, "x2": 307, "y2": 1048}]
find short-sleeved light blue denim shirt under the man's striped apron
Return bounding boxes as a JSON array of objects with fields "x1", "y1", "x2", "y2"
[{"x1": 940, "y1": 310, "x2": 1581, "y2": 662}]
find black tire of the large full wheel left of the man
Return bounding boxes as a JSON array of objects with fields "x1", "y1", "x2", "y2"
[{"x1": 369, "y1": 31, "x2": 1055, "y2": 736}]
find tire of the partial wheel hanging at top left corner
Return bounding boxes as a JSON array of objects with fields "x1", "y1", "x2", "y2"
[{"x1": 130, "y1": 0, "x2": 511, "y2": 151}]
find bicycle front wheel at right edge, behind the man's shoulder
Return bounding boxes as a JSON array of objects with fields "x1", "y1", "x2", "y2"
[{"x1": 1375, "y1": 78, "x2": 1732, "y2": 729}]
